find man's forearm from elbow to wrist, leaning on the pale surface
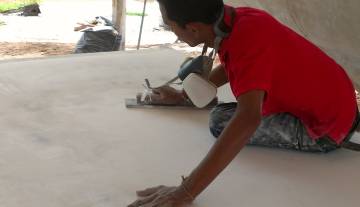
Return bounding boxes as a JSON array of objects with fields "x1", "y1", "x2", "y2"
[{"x1": 183, "y1": 110, "x2": 260, "y2": 197}]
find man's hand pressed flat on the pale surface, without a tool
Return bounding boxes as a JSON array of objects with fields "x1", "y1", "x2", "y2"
[{"x1": 128, "y1": 186, "x2": 192, "y2": 207}]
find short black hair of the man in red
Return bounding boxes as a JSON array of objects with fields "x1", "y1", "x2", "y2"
[{"x1": 157, "y1": 0, "x2": 224, "y2": 28}]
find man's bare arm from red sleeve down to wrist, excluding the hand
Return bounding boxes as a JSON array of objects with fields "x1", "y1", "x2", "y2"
[{"x1": 183, "y1": 91, "x2": 264, "y2": 197}]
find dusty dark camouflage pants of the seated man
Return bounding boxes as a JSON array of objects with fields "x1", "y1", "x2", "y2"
[{"x1": 209, "y1": 103, "x2": 339, "y2": 152}]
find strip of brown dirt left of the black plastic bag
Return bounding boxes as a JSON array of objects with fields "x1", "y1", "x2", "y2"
[{"x1": 0, "y1": 42, "x2": 75, "y2": 60}]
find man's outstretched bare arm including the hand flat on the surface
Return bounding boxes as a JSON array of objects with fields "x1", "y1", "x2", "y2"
[{"x1": 129, "y1": 91, "x2": 264, "y2": 207}]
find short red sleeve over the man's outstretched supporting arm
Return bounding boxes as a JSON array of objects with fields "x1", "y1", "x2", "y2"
[{"x1": 225, "y1": 13, "x2": 276, "y2": 97}]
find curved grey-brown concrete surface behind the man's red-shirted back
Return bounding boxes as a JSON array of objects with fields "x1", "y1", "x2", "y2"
[{"x1": 225, "y1": 0, "x2": 360, "y2": 84}]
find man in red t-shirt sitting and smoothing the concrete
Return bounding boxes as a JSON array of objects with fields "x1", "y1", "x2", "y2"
[{"x1": 130, "y1": 0, "x2": 358, "y2": 207}]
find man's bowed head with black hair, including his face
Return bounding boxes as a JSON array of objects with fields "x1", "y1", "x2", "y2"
[{"x1": 158, "y1": 0, "x2": 224, "y2": 46}]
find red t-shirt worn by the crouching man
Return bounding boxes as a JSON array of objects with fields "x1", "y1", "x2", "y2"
[{"x1": 219, "y1": 8, "x2": 357, "y2": 144}]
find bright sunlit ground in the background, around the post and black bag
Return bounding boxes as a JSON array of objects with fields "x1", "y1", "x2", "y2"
[{"x1": 0, "y1": 0, "x2": 176, "y2": 60}]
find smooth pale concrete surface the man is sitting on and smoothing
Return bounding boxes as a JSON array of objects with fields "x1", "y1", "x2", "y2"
[{"x1": 0, "y1": 49, "x2": 360, "y2": 207}]
